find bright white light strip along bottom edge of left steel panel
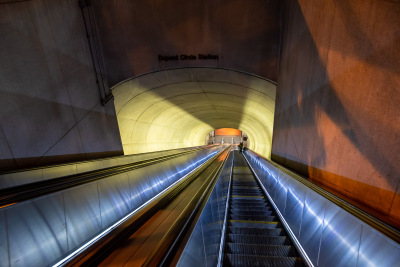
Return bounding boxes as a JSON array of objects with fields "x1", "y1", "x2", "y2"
[{"x1": 53, "y1": 151, "x2": 219, "y2": 267}]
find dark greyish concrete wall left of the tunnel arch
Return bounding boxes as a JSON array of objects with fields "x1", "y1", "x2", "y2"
[{"x1": 0, "y1": 0, "x2": 122, "y2": 172}]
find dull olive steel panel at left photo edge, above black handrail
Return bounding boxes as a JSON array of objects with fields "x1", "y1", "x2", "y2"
[{"x1": 0, "y1": 170, "x2": 43, "y2": 189}]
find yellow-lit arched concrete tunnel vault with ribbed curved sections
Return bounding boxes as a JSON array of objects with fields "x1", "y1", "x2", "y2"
[{"x1": 113, "y1": 68, "x2": 276, "y2": 157}]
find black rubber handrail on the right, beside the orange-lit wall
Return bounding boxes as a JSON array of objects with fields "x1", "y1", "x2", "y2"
[{"x1": 245, "y1": 151, "x2": 400, "y2": 243}]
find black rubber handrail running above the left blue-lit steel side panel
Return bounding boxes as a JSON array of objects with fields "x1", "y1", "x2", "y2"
[{"x1": 0, "y1": 147, "x2": 212, "y2": 209}]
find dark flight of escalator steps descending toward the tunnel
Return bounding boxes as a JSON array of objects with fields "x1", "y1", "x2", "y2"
[{"x1": 223, "y1": 151, "x2": 304, "y2": 266}]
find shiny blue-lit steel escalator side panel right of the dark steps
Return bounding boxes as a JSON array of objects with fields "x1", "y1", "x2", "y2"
[{"x1": 245, "y1": 150, "x2": 400, "y2": 266}]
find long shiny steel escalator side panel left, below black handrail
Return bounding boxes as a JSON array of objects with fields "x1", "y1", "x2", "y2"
[{"x1": 0, "y1": 148, "x2": 221, "y2": 266}]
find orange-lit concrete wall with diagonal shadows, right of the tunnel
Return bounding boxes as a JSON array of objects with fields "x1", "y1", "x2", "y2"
[{"x1": 272, "y1": 0, "x2": 400, "y2": 227}]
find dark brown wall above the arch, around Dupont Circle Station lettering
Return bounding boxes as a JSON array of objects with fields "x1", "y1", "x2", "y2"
[{"x1": 93, "y1": 0, "x2": 280, "y2": 85}]
